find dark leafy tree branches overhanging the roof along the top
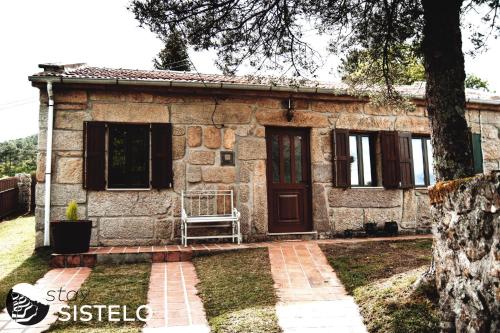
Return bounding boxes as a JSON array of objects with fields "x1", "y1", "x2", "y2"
[{"x1": 129, "y1": 0, "x2": 500, "y2": 79}]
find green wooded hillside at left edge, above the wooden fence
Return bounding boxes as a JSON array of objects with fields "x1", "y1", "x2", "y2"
[{"x1": 0, "y1": 135, "x2": 38, "y2": 178}]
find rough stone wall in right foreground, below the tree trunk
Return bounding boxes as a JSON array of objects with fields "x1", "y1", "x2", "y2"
[{"x1": 433, "y1": 172, "x2": 500, "y2": 332}]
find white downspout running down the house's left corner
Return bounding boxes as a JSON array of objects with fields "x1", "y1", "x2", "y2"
[{"x1": 43, "y1": 81, "x2": 54, "y2": 246}]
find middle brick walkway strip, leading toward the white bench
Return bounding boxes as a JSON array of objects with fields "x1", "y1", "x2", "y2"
[{"x1": 143, "y1": 262, "x2": 210, "y2": 333}]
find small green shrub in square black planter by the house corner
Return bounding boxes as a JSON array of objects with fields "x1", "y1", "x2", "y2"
[{"x1": 50, "y1": 200, "x2": 92, "y2": 254}]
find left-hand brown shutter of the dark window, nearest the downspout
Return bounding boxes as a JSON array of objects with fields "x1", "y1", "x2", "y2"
[{"x1": 83, "y1": 121, "x2": 106, "y2": 191}]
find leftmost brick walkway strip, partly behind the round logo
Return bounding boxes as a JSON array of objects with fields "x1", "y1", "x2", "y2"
[{"x1": 0, "y1": 267, "x2": 91, "y2": 333}]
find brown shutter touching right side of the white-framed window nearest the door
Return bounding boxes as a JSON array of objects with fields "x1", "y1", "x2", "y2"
[{"x1": 380, "y1": 132, "x2": 401, "y2": 188}]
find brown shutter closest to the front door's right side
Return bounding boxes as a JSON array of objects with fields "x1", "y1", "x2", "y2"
[{"x1": 332, "y1": 129, "x2": 351, "y2": 188}]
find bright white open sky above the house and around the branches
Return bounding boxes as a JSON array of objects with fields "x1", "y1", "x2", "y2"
[{"x1": 0, "y1": 0, "x2": 500, "y2": 142}]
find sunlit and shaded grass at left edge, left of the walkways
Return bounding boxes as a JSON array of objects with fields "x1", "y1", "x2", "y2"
[{"x1": 0, "y1": 216, "x2": 50, "y2": 309}]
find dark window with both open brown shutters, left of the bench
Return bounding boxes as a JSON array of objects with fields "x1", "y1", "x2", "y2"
[{"x1": 83, "y1": 121, "x2": 173, "y2": 191}]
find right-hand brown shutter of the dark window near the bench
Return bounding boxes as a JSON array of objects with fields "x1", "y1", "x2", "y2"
[{"x1": 151, "y1": 124, "x2": 173, "y2": 189}]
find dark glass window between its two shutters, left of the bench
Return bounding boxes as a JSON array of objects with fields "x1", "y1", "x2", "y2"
[{"x1": 108, "y1": 124, "x2": 150, "y2": 188}]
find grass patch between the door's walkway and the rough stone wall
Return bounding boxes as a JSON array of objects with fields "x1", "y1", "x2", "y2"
[{"x1": 322, "y1": 239, "x2": 439, "y2": 333}]
